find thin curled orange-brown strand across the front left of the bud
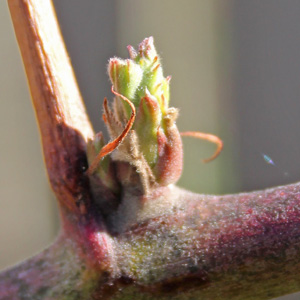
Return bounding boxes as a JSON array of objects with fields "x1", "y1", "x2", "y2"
[{"x1": 87, "y1": 86, "x2": 136, "y2": 175}]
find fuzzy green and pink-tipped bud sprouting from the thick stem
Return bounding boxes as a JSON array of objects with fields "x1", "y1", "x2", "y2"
[{"x1": 88, "y1": 37, "x2": 182, "y2": 193}]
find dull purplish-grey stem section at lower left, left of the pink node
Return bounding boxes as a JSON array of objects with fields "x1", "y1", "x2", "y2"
[{"x1": 0, "y1": 231, "x2": 109, "y2": 300}]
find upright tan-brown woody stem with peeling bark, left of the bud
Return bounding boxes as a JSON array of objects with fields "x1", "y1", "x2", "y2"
[{"x1": 8, "y1": 0, "x2": 93, "y2": 211}]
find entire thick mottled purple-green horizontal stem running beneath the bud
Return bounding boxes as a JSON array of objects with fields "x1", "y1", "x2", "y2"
[{"x1": 0, "y1": 183, "x2": 300, "y2": 300}]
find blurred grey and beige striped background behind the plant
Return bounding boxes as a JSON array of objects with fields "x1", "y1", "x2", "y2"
[{"x1": 0, "y1": 0, "x2": 300, "y2": 299}]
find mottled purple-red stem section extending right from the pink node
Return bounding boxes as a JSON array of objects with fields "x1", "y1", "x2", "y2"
[{"x1": 108, "y1": 183, "x2": 300, "y2": 300}]
